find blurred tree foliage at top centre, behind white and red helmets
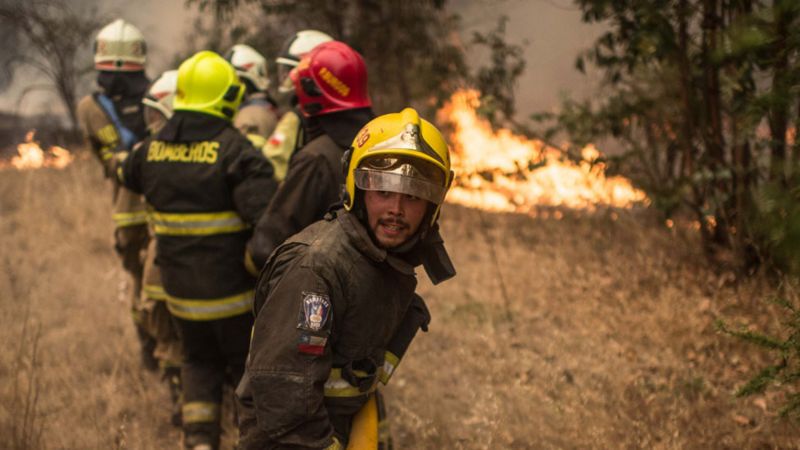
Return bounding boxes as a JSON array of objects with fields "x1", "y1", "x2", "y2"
[{"x1": 184, "y1": 0, "x2": 467, "y2": 113}]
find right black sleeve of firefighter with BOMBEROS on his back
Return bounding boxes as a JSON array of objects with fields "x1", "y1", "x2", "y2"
[{"x1": 226, "y1": 136, "x2": 278, "y2": 225}]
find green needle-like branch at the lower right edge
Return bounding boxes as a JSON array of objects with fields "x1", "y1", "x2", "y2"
[{"x1": 717, "y1": 290, "x2": 800, "y2": 419}]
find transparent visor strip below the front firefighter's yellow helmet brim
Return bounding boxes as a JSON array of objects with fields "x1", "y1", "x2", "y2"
[{"x1": 354, "y1": 164, "x2": 447, "y2": 205}]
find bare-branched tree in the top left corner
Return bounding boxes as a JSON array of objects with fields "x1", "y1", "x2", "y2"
[{"x1": 0, "y1": 0, "x2": 103, "y2": 133}]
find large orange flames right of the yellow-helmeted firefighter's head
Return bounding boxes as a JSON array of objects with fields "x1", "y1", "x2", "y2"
[{"x1": 438, "y1": 90, "x2": 647, "y2": 215}]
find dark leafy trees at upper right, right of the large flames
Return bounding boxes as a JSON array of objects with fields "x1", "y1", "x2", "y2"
[{"x1": 533, "y1": 0, "x2": 800, "y2": 270}]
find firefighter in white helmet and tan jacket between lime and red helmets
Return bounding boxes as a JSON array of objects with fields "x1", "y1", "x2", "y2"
[{"x1": 225, "y1": 44, "x2": 278, "y2": 148}]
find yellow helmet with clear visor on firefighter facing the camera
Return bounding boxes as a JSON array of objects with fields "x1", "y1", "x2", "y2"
[{"x1": 344, "y1": 108, "x2": 453, "y2": 225}]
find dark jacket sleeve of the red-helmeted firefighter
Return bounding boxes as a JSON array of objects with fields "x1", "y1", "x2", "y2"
[{"x1": 247, "y1": 152, "x2": 338, "y2": 268}]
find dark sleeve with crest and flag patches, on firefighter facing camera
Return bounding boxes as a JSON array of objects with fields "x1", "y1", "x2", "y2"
[{"x1": 237, "y1": 255, "x2": 341, "y2": 450}]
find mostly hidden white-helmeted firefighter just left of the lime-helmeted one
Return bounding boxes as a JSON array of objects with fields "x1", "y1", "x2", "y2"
[{"x1": 141, "y1": 70, "x2": 182, "y2": 426}]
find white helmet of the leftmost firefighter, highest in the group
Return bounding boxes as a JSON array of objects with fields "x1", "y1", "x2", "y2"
[{"x1": 94, "y1": 19, "x2": 147, "y2": 72}]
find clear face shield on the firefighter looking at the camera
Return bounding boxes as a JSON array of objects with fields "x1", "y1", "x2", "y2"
[{"x1": 354, "y1": 156, "x2": 447, "y2": 205}]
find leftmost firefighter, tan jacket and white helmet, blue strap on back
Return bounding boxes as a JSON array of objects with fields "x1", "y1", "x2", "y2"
[{"x1": 77, "y1": 19, "x2": 158, "y2": 370}]
